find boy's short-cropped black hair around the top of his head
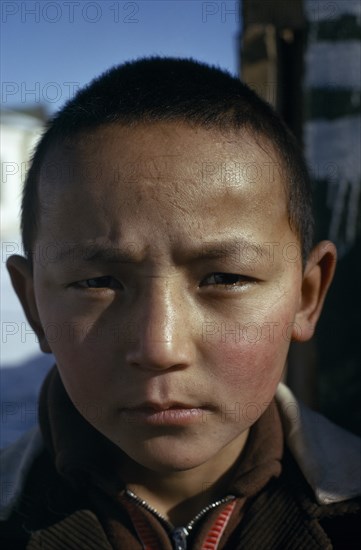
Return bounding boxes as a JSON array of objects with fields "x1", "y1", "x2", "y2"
[{"x1": 21, "y1": 57, "x2": 314, "y2": 261}]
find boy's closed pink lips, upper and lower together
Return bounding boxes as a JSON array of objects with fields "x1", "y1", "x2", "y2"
[{"x1": 121, "y1": 402, "x2": 209, "y2": 426}]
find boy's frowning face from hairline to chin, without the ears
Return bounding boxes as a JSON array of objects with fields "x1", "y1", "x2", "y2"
[{"x1": 15, "y1": 123, "x2": 310, "y2": 471}]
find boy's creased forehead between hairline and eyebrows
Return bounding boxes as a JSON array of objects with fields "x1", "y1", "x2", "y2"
[{"x1": 39, "y1": 122, "x2": 288, "y2": 248}]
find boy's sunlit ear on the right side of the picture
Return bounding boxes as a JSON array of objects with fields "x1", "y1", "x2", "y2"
[{"x1": 292, "y1": 241, "x2": 337, "y2": 342}]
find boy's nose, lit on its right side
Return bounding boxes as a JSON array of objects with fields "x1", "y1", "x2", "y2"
[{"x1": 126, "y1": 277, "x2": 194, "y2": 371}]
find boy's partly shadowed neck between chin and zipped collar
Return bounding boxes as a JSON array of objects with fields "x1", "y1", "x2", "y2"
[{"x1": 122, "y1": 432, "x2": 248, "y2": 525}]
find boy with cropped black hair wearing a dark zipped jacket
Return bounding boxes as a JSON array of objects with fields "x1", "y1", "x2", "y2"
[{"x1": 3, "y1": 58, "x2": 360, "y2": 550}]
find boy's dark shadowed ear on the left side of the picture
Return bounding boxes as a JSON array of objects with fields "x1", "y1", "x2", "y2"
[{"x1": 6, "y1": 255, "x2": 52, "y2": 353}]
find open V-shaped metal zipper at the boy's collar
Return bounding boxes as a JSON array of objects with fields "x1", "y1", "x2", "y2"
[{"x1": 125, "y1": 489, "x2": 236, "y2": 550}]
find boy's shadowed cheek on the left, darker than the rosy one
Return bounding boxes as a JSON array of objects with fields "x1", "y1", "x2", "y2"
[{"x1": 32, "y1": 296, "x2": 126, "y2": 409}]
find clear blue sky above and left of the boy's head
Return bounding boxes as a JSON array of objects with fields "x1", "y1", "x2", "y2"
[{"x1": 1, "y1": 0, "x2": 241, "y2": 112}]
